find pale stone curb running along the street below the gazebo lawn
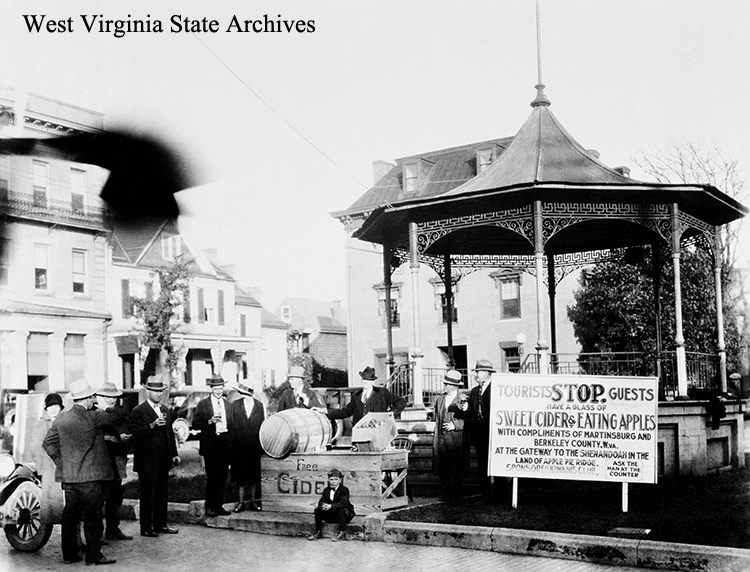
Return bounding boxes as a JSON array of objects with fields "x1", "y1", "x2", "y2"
[{"x1": 122, "y1": 499, "x2": 750, "y2": 572}]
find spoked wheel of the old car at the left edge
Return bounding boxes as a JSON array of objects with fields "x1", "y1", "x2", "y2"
[{"x1": 5, "y1": 482, "x2": 52, "y2": 552}]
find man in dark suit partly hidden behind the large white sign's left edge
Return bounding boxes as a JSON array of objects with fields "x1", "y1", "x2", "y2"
[{"x1": 448, "y1": 359, "x2": 495, "y2": 502}]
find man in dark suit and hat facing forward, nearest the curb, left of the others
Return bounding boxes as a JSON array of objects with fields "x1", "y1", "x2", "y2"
[{"x1": 130, "y1": 375, "x2": 180, "y2": 537}]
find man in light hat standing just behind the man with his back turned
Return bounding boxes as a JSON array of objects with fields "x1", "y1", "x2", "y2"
[{"x1": 96, "y1": 381, "x2": 133, "y2": 540}]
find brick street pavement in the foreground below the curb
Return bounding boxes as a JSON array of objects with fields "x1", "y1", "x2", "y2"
[{"x1": 0, "y1": 521, "x2": 642, "y2": 572}]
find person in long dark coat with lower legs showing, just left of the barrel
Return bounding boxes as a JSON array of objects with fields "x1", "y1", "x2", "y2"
[{"x1": 230, "y1": 380, "x2": 266, "y2": 512}]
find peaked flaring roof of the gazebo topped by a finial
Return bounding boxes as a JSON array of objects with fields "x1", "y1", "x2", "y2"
[{"x1": 354, "y1": 86, "x2": 748, "y2": 254}]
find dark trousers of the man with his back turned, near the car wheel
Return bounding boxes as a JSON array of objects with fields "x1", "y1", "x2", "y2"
[{"x1": 62, "y1": 481, "x2": 106, "y2": 562}]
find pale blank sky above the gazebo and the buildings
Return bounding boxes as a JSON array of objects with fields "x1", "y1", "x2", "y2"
[{"x1": 0, "y1": 0, "x2": 750, "y2": 310}]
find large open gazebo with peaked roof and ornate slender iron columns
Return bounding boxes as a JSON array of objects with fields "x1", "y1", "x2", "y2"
[{"x1": 354, "y1": 83, "x2": 748, "y2": 473}]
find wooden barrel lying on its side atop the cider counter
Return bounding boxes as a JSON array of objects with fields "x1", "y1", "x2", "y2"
[{"x1": 260, "y1": 407, "x2": 332, "y2": 459}]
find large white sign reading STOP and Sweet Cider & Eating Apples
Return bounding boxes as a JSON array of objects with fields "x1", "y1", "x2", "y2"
[{"x1": 489, "y1": 374, "x2": 658, "y2": 483}]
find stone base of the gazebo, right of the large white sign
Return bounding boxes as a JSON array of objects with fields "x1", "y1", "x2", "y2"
[{"x1": 657, "y1": 400, "x2": 747, "y2": 477}]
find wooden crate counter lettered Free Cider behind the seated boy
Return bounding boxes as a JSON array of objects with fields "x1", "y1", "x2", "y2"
[{"x1": 261, "y1": 450, "x2": 409, "y2": 515}]
